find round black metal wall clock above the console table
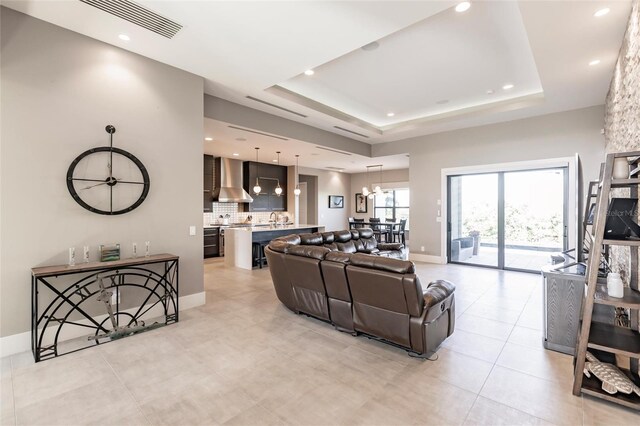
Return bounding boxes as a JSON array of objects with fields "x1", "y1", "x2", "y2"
[{"x1": 67, "y1": 125, "x2": 151, "y2": 215}]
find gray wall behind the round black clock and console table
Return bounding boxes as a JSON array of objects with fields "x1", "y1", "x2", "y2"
[{"x1": 0, "y1": 8, "x2": 203, "y2": 336}]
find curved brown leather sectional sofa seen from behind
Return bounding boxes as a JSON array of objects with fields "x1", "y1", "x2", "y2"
[{"x1": 265, "y1": 228, "x2": 455, "y2": 357}]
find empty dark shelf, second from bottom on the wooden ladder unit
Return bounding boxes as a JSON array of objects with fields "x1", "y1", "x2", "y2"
[{"x1": 587, "y1": 322, "x2": 640, "y2": 358}]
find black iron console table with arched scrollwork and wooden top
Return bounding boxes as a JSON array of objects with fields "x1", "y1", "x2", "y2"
[{"x1": 31, "y1": 254, "x2": 179, "y2": 362}]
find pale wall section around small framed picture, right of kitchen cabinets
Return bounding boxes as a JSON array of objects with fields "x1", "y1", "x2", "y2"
[{"x1": 299, "y1": 167, "x2": 352, "y2": 231}]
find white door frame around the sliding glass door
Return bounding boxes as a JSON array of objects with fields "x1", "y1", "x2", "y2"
[{"x1": 438, "y1": 153, "x2": 580, "y2": 264}]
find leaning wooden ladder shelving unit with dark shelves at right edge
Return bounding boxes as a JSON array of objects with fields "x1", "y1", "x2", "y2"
[{"x1": 573, "y1": 152, "x2": 640, "y2": 410}]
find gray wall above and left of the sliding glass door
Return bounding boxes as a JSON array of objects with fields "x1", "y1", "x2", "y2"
[{"x1": 372, "y1": 106, "x2": 604, "y2": 256}]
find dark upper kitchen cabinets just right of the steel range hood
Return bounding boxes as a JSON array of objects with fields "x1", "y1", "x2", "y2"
[{"x1": 242, "y1": 161, "x2": 287, "y2": 212}]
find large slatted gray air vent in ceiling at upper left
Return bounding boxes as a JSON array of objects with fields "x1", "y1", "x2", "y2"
[{"x1": 80, "y1": 0, "x2": 182, "y2": 38}]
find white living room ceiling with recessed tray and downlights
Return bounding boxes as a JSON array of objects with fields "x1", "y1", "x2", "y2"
[{"x1": 2, "y1": 0, "x2": 630, "y2": 143}]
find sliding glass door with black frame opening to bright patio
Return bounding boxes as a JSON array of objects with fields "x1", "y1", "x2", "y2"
[{"x1": 447, "y1": 168, "x2": 568, "y2": 272}]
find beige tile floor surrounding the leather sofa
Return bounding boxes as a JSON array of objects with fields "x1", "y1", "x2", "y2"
[{"x1": 0, "y1": 260, "x2": 640, "y2": 425}]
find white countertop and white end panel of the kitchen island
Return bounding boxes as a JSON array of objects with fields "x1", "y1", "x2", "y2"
[{"x1": 224, "y1": 224, "x2": 324, "y2": 269}]
